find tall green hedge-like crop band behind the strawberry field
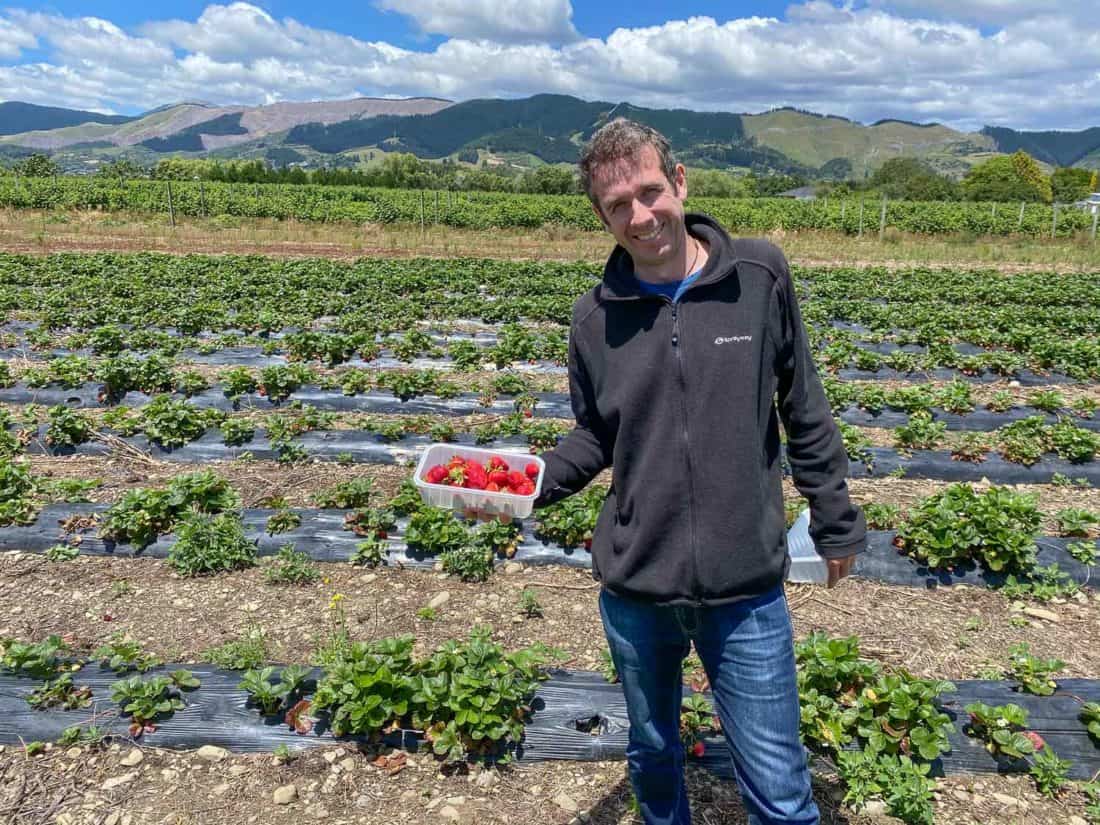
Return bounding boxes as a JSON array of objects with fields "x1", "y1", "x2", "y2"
[{"x1": 0, "y1": 176, "x2": 1095, "y2": 237}]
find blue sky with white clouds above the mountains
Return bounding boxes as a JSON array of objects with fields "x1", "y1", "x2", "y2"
[{"x1": 0, "y1": 0, "x2": 1100, "y2": 129}]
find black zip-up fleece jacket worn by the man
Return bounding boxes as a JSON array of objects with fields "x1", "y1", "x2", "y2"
[{"x1": 537, "y1": 213, "x2": 866, "y2": 605}]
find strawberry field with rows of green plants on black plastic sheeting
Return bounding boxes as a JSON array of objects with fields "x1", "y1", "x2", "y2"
[{"x1": 0, "y1": 247, "x2": 1100, "y2": 825}]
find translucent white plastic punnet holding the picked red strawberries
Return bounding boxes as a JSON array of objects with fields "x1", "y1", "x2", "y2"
[{"x1": 415, "y1": 443, "x2": 546, "y2": 518}]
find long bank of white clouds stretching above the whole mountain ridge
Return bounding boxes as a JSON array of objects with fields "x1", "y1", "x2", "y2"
[{"x1": 0, "y1": 0, "x2": 1100, "y2": 129}]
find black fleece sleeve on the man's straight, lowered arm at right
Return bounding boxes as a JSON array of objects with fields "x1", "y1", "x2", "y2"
[{"x1": 770, "y1": 251, "x2": 867, "y2": 559}]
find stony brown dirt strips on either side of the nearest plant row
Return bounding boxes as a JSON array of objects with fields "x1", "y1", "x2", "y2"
[{"x1": 0, "y1": 553, "x2": 1100, "y2": 825}]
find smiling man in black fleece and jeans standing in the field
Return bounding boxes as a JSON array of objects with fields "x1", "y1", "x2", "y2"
[{"x1": 538, "y1": 119, "x2": 865, "y2": 825}]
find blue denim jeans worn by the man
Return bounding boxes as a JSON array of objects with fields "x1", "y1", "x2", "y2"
[{"x1": 600, "y1": 585, "x2": 818, "y2": 825}]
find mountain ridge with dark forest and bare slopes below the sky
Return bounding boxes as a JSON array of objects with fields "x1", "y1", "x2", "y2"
[{"x1": 0, "y1": 94, "x2": 1100, "y2": 178}]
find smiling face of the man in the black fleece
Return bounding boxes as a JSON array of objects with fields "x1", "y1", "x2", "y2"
[{"x1": 593, "y1": 146, "x2": 688, "y2": 268}]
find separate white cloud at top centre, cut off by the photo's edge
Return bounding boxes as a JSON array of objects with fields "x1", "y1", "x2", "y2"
[{"x1": 374, "y1": 0, "x2": 580, "y2": 43}]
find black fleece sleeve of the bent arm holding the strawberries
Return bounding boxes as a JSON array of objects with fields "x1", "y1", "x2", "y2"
[{"x1": 535, "y1": 329, "x2": 615, "y2": 507}]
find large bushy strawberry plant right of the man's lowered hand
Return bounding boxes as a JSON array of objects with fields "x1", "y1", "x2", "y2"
[{"x1": 894, "y1": 484, "x2": 1042, "y2": 572}]
